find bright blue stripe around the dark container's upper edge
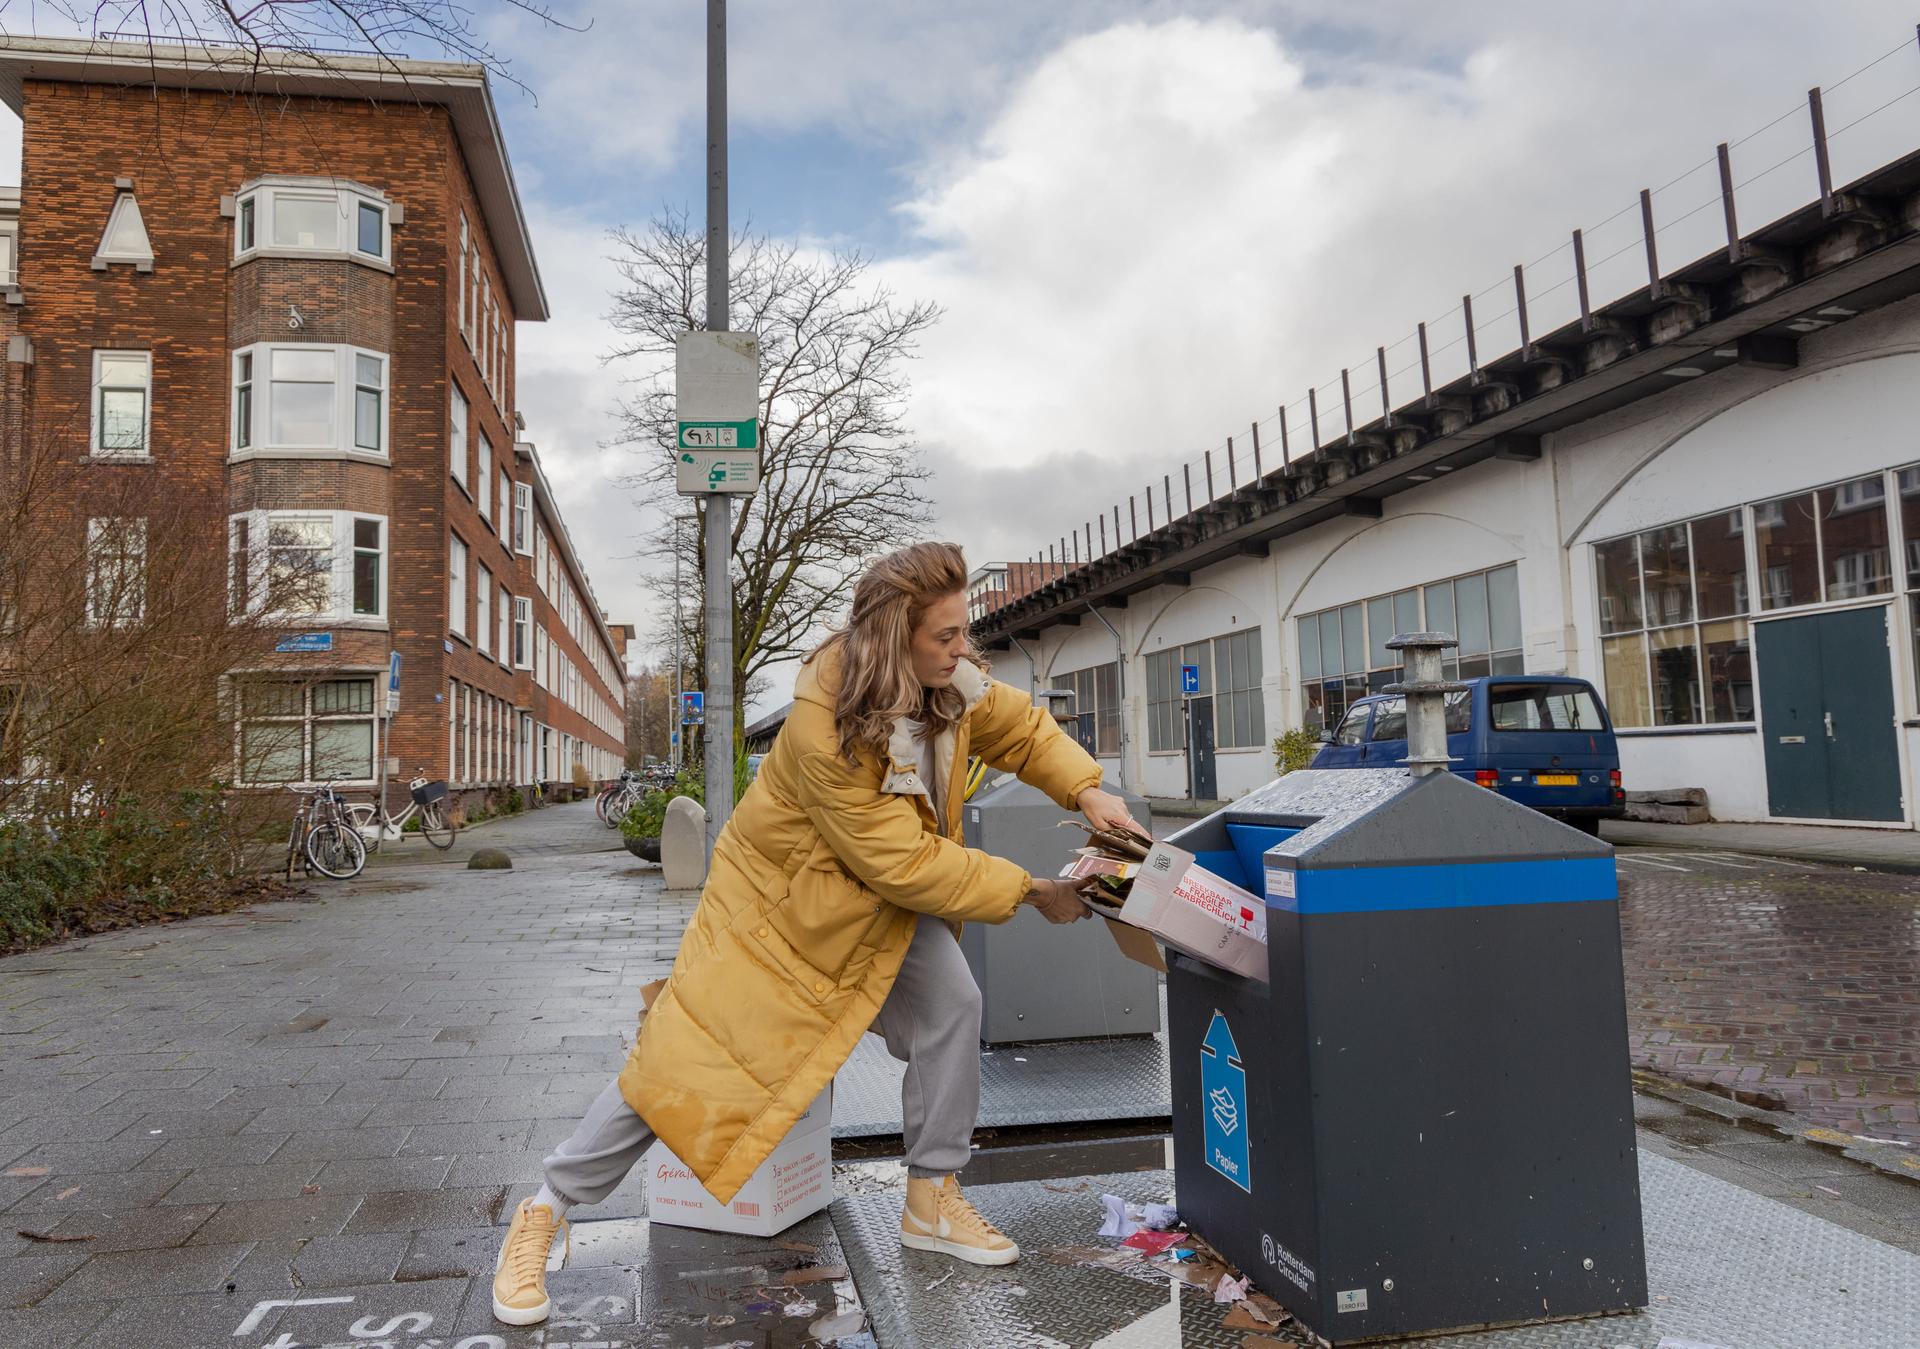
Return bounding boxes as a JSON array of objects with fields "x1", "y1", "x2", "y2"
[{"x1": 1267, "y1": 858, "x2": 1619, "y2": 913}]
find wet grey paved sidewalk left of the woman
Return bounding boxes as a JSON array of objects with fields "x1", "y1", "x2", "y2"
[{"x1": 0, "y1": 804, "x2": 871, "y2": 1349}]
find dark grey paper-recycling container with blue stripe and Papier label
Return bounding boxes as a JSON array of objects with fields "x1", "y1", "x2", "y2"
[{"x1": 1167, "y1": 637, "x2": 1647, "y2": 1345}]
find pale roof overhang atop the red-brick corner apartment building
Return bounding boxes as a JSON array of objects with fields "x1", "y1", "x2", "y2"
[{"x1": 0, "y1": 35, "x2": 549, "y2": 320}]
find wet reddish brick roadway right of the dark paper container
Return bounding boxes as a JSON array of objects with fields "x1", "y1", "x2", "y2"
[{"x1": 1620, "y1": 850, "x2": 1920, "y2": 1144}]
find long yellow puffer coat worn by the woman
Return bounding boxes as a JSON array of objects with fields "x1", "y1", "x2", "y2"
[{"x1": 620, "y1": 652, "x2": 1100, "y2": 1203}]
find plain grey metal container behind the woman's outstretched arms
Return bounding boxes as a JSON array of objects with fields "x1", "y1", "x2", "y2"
[{"x1": 960, "y1": 775, "x2": 1160, "y2": 1044}]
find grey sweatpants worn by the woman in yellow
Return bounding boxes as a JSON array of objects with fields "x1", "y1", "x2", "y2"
[{"x1": 545, "y1": 915, "x2": 979, "y2": 1203}]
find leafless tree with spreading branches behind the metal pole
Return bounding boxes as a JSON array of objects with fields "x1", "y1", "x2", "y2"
[{"x1": 609, "y1": 211, "x2": 941, "y2": 737}]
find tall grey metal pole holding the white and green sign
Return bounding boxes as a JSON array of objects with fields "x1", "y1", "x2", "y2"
[{"x1": 707, "y1": 0, "x2": 733, "y2": 856}]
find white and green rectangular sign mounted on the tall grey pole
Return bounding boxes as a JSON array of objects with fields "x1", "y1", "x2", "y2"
[{"x1": 674, "y1": 332, "x2": 760, "y2": 497}]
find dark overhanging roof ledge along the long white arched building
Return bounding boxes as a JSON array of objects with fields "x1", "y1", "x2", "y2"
[{"x1": 972, "y1": 152, "x2": 1920, "y2": 649}]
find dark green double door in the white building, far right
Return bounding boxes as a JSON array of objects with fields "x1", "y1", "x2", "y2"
[{"x1": 1753, "y1": 606, "x2": 1901, "y2": 819}]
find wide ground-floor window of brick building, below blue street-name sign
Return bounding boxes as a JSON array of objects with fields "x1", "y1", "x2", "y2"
[{"x1": 236, "y1": 675, "x2": 374, "y2": 787}]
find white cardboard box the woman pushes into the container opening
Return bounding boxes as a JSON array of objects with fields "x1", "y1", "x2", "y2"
[{"x1": 1092, "y1": 842, "x2": 1267, "y2": 982}]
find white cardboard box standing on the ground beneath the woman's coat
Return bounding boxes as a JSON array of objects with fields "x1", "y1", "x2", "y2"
[{"x1": 647, "y1": 1084, "x2": 833, "y2": 1236}]
